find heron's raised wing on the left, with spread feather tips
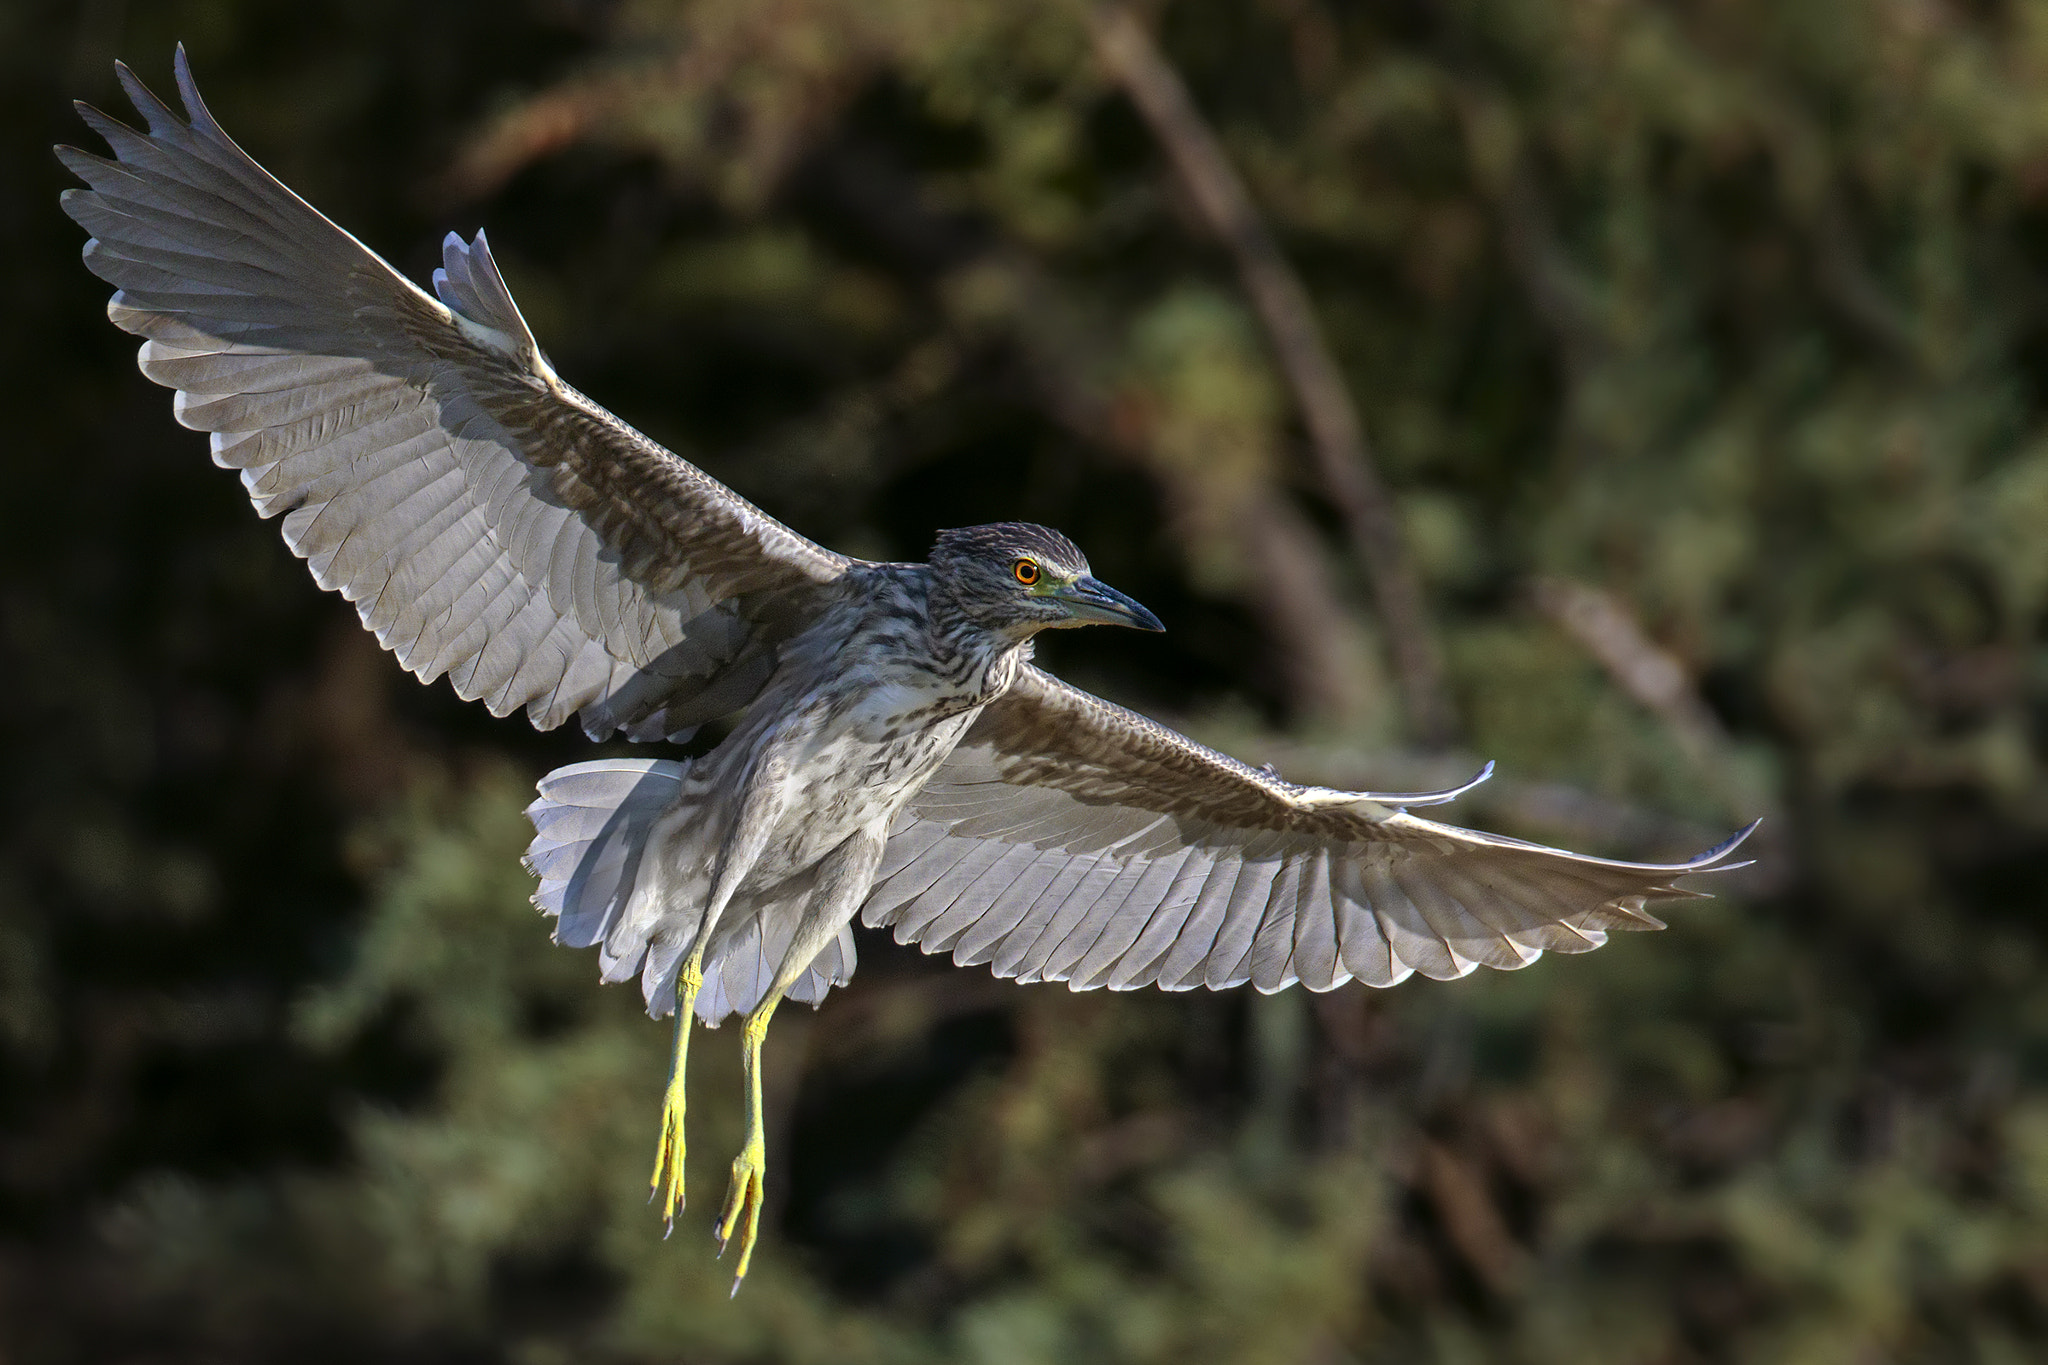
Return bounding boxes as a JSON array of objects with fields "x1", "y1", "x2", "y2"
[{"x1": 57, "y1": 47, "x2": 850, "y2": 739}]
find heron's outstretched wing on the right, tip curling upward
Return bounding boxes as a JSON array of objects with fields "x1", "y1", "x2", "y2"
[{"x1": 862, "y1": 667, "x2": 1755, "y2": 990}]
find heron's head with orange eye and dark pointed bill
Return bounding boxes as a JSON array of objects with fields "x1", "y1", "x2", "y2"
[{"x1": 932, "y1": 522, "x2": 1165, "y2": 641}]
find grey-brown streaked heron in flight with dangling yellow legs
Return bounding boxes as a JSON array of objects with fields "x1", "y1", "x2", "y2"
[{"x1": 57, "y1": 47, "x2": 1749, "y2": 1291}]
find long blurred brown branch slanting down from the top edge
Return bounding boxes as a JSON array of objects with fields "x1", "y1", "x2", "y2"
[{"x1": 1090, "y1": 4, "x2": 1456, "y2": 747}]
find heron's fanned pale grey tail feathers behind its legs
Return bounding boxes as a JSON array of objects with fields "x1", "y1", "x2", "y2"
[{"x1": 526, "y1": 759, "x2": 854, "y2": 1027}]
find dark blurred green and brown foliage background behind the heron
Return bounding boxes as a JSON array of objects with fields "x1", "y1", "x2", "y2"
[{"x1": 0, "y1": 0, "x2": 2048, "y2": 1365}]
